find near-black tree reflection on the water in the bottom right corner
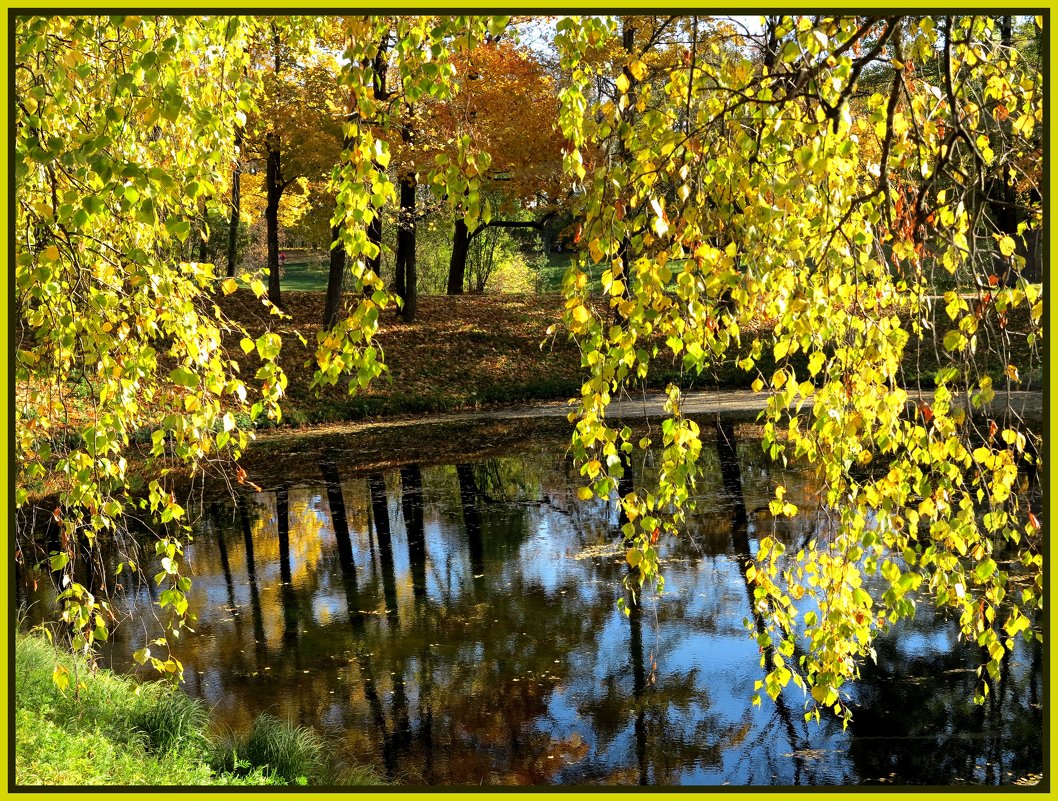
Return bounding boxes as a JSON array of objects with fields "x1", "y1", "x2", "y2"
[{"x1": 850, "y1": 605, "x2": 1043, "y2": 785}]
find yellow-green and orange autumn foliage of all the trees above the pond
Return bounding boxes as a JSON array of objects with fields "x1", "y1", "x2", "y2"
[{"x1": 12, "y1": 15, "x2": 1044, "y2": 716}]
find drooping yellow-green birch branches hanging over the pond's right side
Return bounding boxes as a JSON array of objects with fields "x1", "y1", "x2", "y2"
[{"x1": 557, "y1": 16, "x2": 1043, "y2": 715}]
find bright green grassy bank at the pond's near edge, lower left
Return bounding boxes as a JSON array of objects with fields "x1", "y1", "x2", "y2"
[{"x1": 15, "y1": 634, "x2": 380, "y2": 786}]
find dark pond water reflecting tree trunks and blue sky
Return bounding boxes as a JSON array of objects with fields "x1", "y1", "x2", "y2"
[{"x1": 16, "y1": 426, "x2": 1043, "y2": 785}]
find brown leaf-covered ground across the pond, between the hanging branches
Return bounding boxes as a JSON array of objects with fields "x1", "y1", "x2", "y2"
[{"x1": 220, "y1": 290, "x2": 651, "y2": 425}]
